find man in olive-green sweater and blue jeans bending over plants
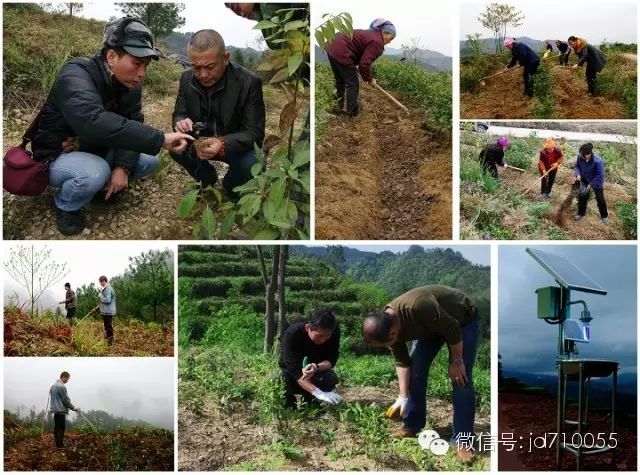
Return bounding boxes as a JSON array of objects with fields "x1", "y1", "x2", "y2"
[{"x1": 362, "y1": 285, "x2": 478, "y2": 459}]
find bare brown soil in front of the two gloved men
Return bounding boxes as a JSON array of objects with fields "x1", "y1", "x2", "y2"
[{"x1": 178, "y1": 387, "x2": 491, "y2": 471}]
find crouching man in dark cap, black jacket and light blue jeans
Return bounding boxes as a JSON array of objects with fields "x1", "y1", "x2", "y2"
[{"x1": 32, "y1": 17, "x2": 191, "y2": 235}]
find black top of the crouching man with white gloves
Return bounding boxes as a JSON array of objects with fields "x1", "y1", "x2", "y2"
[{"x1": 279, "y1": 321, "x2": 340, "y2": 380}]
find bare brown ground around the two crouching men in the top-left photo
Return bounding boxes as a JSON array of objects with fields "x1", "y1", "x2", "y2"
[{"x1": 3, "y1": 85, "x2": 307, "y2": 240}]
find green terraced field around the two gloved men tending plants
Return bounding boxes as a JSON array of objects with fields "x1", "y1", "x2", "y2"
[{"x1": 179, "y1": 246, "x2": 490, "y2": 471}]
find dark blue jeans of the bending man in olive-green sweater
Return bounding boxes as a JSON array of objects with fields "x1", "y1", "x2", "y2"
[{"x1": 403, "y1": 320, "x2": 479, "y2": 441}]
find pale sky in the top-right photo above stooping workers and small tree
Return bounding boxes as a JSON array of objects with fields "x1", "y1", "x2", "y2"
[{"x1": 460, "y1": 0, "x2": 637, "y2": 43}]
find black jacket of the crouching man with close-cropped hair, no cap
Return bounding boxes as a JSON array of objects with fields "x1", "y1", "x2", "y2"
[{"x1": 173, "y1": 62, "x2": 265, "y2": 154}]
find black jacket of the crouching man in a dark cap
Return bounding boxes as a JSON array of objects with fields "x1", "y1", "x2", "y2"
[{"x1": 31, "y1": 54, "x2": 164, "y2": 170}]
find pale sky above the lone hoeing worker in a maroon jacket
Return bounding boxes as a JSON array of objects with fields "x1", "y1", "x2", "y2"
[{"x1": 311, "y1": 0, "x2": 457, "y2": 56}]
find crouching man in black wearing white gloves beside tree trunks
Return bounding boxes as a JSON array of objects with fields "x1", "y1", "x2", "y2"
[{"x1": 279, "y1": 308, "x2": 342, "y2": 408}]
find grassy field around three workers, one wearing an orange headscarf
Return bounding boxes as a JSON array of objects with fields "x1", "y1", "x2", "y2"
[{"x1": 460, "y1": 131, "x2": 637, "y2": 240}]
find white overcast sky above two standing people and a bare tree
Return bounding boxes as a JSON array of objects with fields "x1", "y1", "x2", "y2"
[{"x1": 4, "y1": 245, "x2": 168, "y2": 307}]
